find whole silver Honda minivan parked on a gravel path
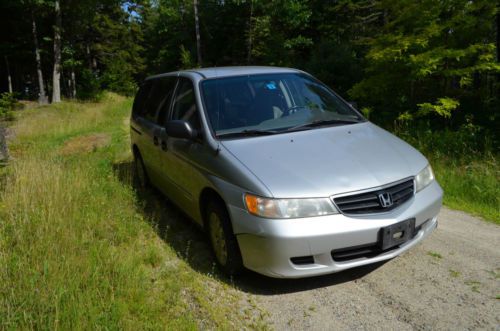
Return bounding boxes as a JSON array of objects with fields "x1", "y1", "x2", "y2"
[{"x1": 131, "y1": 67, "x2": 443, "y2": 278}]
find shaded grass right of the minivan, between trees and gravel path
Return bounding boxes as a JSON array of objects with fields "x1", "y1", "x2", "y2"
[{"x1": 398, "y1": 125, "x2": 500, "y2": 224}]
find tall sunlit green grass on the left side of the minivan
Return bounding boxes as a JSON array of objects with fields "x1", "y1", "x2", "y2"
[{"x1": 0, "y1": 95, "x2": 258, "y2": 330}]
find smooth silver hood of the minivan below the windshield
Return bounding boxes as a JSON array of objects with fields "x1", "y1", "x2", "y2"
[{"x1": 221, "y1": 122, "x2": 427, "y2": 198}]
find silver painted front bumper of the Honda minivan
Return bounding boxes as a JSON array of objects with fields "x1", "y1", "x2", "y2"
[{"x1": 229, "y1": 181, "x2": 443, "y2": 278}]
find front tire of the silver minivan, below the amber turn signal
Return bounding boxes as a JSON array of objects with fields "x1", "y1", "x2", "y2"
[{"x1": 205, "y1": 201, "x2": 244, "y2": 276}]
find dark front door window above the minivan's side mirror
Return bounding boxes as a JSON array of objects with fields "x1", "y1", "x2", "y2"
[{"x1": 171, "y1": 77, "x2": 201, "y2": 129}]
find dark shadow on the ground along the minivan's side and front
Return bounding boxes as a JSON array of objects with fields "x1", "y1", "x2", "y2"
[{"x1": 113, "y1": 161, "x2": 384, "y2": 295}]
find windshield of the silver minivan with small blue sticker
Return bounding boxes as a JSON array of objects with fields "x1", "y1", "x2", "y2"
[{"x1": 201, "y1": 73, "x2": 363, "y2": 137}]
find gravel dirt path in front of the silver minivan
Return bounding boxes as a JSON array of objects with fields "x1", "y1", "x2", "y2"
[{"x1": 237, "y1": 209, "x2": 500, "y2": 330}]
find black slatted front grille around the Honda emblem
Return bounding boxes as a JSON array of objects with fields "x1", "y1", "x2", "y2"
[{"x1": 333, "y1": 179, "x2": 414, "y2": 215}]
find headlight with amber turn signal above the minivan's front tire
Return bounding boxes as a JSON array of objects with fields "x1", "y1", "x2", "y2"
[{"x1": 245, "y1": 194, "x2": 338, "y2": 218}]
